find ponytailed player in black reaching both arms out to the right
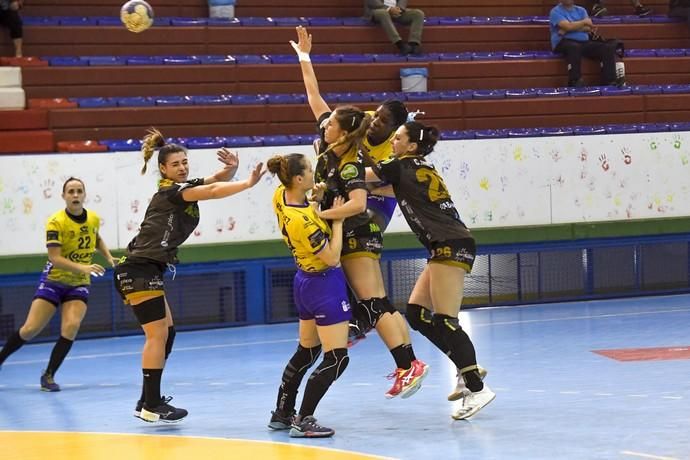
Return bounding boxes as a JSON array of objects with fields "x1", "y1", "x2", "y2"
[{"x1": 115, "y1": 129, "x2": 265, "y2": 422}]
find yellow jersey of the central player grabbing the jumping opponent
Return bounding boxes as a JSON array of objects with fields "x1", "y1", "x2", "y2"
[{"x1": 273, "y1": 185, "x2": 331, "y2": 272}]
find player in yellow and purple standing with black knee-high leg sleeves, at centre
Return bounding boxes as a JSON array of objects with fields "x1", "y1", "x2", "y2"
[{"x1": 267, "y1": 153, "x2": 351, "y2": 438}]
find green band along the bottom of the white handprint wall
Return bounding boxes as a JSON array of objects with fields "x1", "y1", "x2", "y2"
[{"x1": 0, "y1": 217, "x2": 690, "y2": 275}]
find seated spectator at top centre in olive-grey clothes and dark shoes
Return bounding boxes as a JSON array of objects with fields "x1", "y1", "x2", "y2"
[{"x1": 364, "y1": 0, "x2": 424, "y2": 56}]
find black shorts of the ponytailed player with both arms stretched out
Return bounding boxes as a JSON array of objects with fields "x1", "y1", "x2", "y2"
[{"x1": 114, "y1": 260, "x2": 165, "y2": 304}]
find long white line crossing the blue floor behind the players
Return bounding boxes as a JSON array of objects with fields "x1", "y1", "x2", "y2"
[{"x1": 3, "y1": 308, "x2": 690, "y2": 366}]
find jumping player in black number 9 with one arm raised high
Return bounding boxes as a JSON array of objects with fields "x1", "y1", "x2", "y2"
[{"x1": 290, "y1": 26, "x2": 429, "y2": 399}]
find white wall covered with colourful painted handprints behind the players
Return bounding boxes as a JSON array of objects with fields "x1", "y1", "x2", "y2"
[{"x1": 0, "y1": 132, "x2": 690, "y2": 255}]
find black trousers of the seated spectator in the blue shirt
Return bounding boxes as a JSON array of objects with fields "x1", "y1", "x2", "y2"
[{"x1": 554, "y1": 38, "x2": 616, "y2": 85}]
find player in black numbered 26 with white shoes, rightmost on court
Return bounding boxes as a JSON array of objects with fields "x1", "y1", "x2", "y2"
[{"x1": 365, "y1": 121, "x2": 496, "y2": 420}]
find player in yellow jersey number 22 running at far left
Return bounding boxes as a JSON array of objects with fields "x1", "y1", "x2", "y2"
[{"x1": 0, "y1": 177, "x2": 115, "y2": 391}]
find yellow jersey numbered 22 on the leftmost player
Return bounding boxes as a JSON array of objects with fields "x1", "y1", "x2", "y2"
[{"x1": 43, "y1": 209, "x2": 101, "y2": 286}]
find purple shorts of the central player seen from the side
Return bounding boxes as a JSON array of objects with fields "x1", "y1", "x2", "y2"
[{"x1": 293, "y1": 267, "x2": 352, "y2": 326}]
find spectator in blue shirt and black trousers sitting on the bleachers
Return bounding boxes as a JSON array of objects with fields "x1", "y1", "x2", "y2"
[{"x1": 549, "y1": 0, "x2": 624, "y2": 87}]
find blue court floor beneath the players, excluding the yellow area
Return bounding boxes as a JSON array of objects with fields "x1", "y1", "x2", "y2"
[{"x1": 0, "y1": 295, "x2": 690, "y2": 460}]
